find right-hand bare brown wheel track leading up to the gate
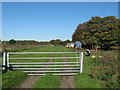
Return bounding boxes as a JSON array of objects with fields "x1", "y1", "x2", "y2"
[{"x1": 60, "y1": 55, "x2": 75, "y2": 88}]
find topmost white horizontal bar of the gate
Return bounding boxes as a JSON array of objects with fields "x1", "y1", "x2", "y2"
[{"x1": 9, "y1": 52, "x2": 80, "y2": 54}]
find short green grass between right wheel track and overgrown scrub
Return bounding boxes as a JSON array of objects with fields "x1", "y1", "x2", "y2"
[{"x1": 74, "y1": 56, "x2": 102, "y2": 88}]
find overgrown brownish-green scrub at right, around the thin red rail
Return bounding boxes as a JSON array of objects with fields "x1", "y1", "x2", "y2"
[{"x1": 93, "y1": 51, "x2": 120, "y2": 88}]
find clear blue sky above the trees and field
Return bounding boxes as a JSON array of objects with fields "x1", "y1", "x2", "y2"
[{"x1": 2, "y1": 2, "x2": 118, "y2": 41}]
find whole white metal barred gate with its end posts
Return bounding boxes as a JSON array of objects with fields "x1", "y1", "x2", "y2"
[{"x1": 3, "y1": 52, "x2": 83, "y2": 75}]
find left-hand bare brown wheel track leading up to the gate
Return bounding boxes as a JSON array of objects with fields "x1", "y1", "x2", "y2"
[{"x1": 20, "y1": 55, "x2": 53, "y2": 88}]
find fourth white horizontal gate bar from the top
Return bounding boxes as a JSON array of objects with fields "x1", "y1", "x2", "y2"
[{"x1": 12, "y1": 65, "x2": 80, "y2": 67}]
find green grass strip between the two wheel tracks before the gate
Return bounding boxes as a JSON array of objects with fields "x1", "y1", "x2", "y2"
[{"x1": 33, "y1": 75, "x2": 60, "y2": 88}]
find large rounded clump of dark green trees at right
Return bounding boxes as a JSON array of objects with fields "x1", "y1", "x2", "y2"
[{"x1": 72, "y1": 16, "x2": 120, "y2": 50}]
